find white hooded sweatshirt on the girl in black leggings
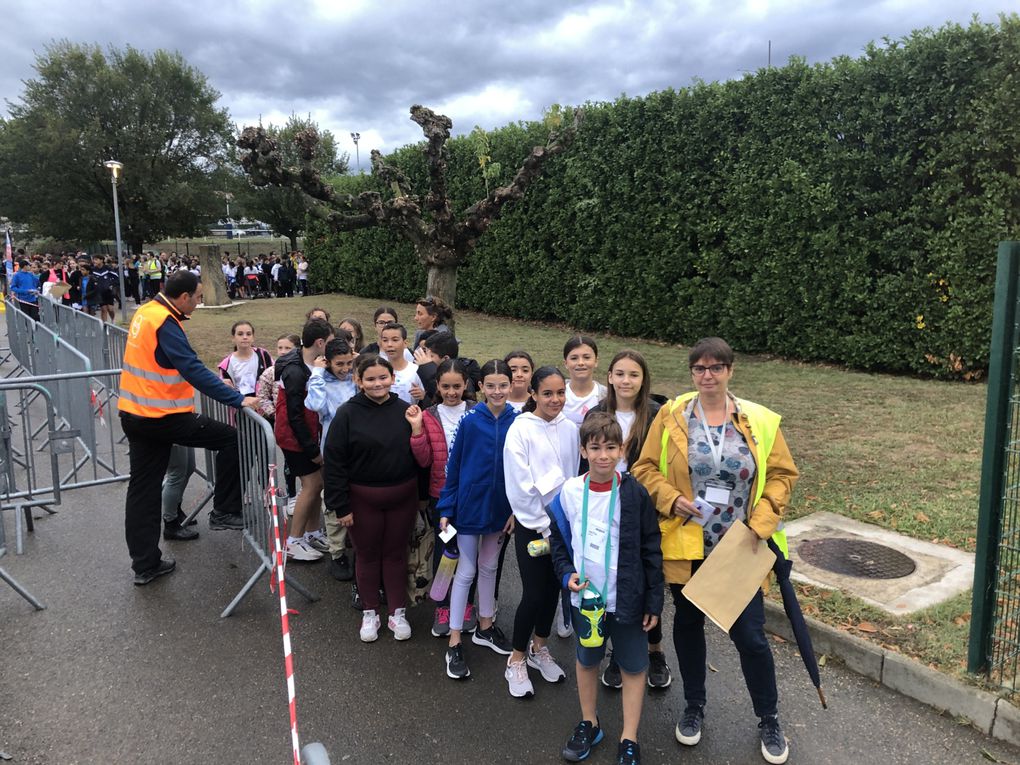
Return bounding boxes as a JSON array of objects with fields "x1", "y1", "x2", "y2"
[{"x1": 503, "y1": 412, "x2": 580, "y2": 537}]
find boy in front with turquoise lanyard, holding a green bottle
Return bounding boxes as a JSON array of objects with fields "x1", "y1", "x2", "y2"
[{"x1": 549, "y1": 412, "x2": 663, "y2": 765}]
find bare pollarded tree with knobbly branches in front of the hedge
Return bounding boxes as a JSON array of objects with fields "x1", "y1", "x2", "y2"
[{"x1": 238, "y1": 105, "x2": 583, "y2": 318}]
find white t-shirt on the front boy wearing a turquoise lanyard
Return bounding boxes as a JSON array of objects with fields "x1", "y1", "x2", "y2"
[{"x1": 560, "y1": 475, "x2": 620, "y2": 613}]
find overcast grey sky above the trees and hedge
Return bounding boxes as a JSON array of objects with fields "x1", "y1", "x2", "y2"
[{"x1": 0, "y1": 0, "x2": 1017, "y2": 166}]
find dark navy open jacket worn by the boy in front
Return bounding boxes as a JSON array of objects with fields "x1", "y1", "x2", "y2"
[{"x1": 547, "y1": 473, "x2": 664, "y2": 624}]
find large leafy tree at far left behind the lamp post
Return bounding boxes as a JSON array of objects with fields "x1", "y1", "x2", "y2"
[{"x1": 0, "y1": 42, "x2": 231, "y2": 250}]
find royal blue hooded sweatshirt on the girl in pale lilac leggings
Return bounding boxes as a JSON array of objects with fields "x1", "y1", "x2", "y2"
[{"x1": 436, "y1": 403, "x2": 517, "y2": 534}]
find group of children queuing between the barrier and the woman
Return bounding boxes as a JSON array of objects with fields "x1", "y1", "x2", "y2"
[{"x1": 213, "y1": 298, "x2": 693, "y2": 763}]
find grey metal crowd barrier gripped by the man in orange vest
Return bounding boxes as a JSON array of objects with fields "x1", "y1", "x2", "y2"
[{"x1": 196, "y1": 393, "x2": 319, "y2": 617}]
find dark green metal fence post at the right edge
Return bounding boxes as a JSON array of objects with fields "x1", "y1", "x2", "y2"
[{"x1": 967, "y1": 242, "x2": 1020, "y2": 672}]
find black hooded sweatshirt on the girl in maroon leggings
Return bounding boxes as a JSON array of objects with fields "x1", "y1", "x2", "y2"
[{"x1": 322, "y1": 393, "x2": 418, "y2": 517}]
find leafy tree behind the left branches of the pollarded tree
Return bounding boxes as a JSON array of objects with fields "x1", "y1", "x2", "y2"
[{"x1": 239, "y1": 114, "x2": 350, "y2": 250}]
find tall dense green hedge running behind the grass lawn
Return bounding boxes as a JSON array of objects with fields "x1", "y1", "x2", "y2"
[{"x1": 308, "y1": 15, "x2": 1020, "y2": 377}]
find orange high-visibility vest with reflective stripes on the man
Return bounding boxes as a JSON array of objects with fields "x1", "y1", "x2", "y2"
[{"x1": 117, "y1": 300, "x2": 195, "y2": 417}]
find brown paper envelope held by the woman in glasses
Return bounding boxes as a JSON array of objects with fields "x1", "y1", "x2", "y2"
[{"x1": 683, "y1": 523, "x2": 775, "y2": 632}]
